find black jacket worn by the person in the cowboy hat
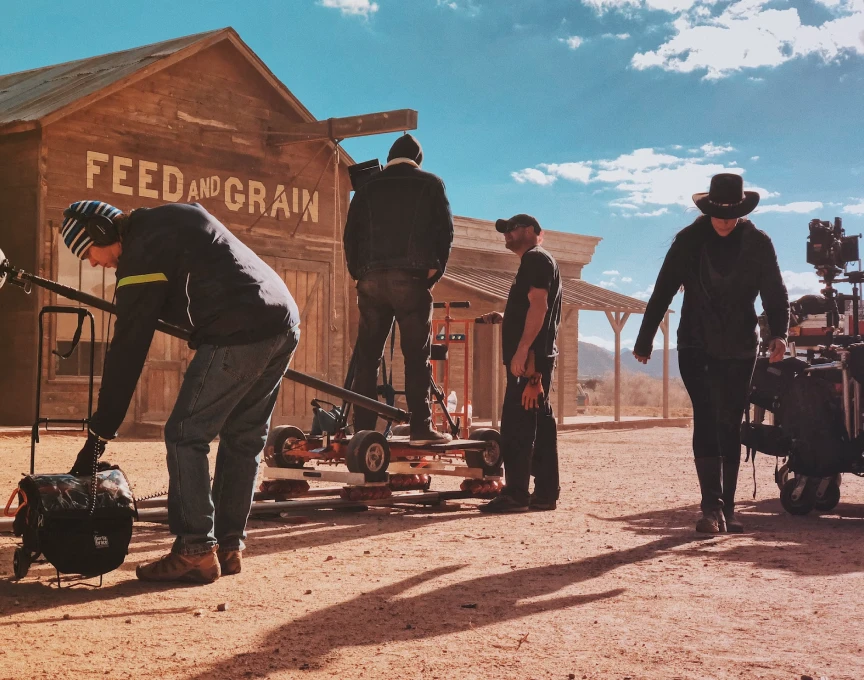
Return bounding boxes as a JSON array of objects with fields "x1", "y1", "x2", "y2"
[{"x1": 634, "y1": 215, "x2": 789, "y2": 359}]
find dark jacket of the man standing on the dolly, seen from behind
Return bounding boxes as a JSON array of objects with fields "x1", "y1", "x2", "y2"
[{"x1": 344, "y1": 162, "x2": 453, "y2": 284}]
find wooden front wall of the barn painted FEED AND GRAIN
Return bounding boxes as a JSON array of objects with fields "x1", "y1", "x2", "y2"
[{"x1": 33, "y1": 42, "x2": 350, "y2": 428}]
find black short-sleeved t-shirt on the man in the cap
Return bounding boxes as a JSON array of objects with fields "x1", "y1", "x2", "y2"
[{"x1": 501, "y1": 246, "x2": 561, "y2": 370}]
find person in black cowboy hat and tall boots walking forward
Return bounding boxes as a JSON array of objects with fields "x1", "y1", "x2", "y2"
[{"x1": 633, "y1": 173, "x2": 789, "y2": 533}]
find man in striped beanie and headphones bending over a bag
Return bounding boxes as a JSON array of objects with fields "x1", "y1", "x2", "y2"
[{"x1": 60, "y1": 201, "x2": 300, "y2": 583}]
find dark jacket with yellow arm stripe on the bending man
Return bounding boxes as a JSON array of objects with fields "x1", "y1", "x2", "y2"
[{"x1": 90, "y1": 204, "x2": 300, "y2": 438}]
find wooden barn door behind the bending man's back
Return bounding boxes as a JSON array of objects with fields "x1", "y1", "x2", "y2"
[{"x1": 262, "y1": 257, "x2": 330, "y2": 429}]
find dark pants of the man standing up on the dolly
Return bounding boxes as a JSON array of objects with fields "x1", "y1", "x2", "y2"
[{"x1": 352, "y1": 269, "x2": 432, "y2": 432}]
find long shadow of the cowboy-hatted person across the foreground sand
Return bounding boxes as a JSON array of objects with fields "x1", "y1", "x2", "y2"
[{"x1": 181, "y1": 534, "x2": 697, "y2": 680}]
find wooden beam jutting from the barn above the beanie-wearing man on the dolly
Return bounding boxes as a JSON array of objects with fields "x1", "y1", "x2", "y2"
[{"x1": 269, "y1": 109, "x2": 417, "y2": 146}]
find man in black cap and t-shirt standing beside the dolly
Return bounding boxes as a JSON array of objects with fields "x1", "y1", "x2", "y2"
[{"x1": 480, "y1": 214, "x2": 561, "y2": 513}]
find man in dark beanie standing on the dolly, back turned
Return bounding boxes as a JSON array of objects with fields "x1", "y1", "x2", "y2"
[{"x1": 344, "y1": 135, "x2": 453, "y2": 445}]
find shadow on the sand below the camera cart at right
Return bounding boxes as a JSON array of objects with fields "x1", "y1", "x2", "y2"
[{"x1": 589, "y1": 499, "x2": 864, "y2": 576}]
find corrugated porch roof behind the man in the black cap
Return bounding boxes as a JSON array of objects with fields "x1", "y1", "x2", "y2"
[{"x1": 444, "y1": 265, "x2": 646, "y2": 314}]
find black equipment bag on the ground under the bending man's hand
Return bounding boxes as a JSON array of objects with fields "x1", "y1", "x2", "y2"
[{"x1": 13, "y1": 467, "x2": 138, "y2": 577}]
